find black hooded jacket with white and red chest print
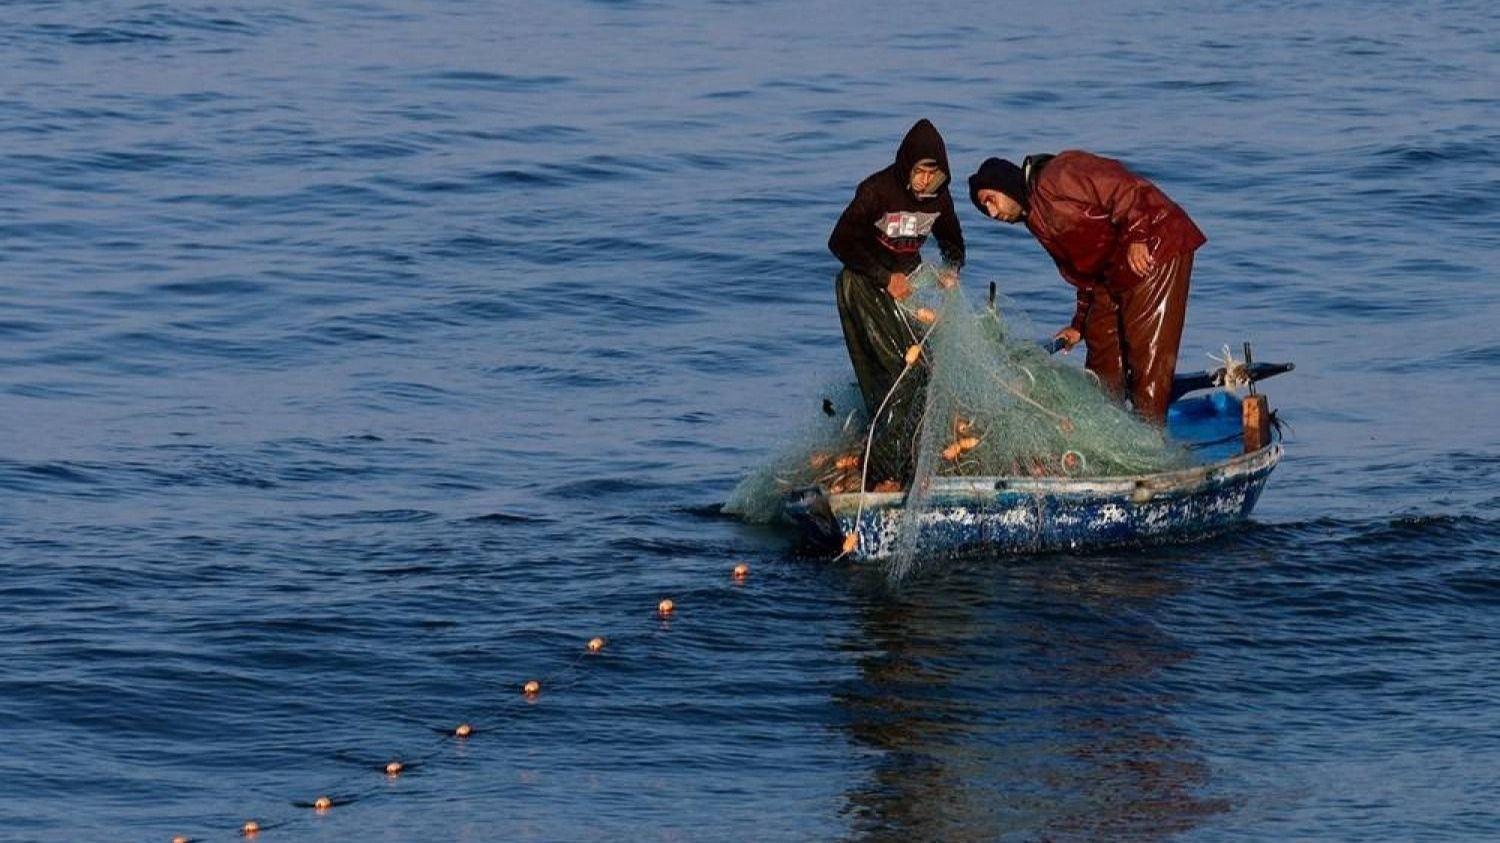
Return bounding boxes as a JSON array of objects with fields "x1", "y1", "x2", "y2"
[{"x1": 828, "y1": 120, "x2": 963, "y2": 279}]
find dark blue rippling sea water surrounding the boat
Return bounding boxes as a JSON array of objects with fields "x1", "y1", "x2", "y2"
[{"x1": 0, "y1": 0, "x2": 1500, "y2": 842}]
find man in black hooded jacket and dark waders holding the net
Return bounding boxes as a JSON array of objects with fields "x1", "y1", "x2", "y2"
[{"x1": 828, "y1": 120, "x2": 963, "y2": 491}]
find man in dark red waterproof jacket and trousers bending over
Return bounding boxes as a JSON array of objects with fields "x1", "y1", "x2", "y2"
[{"x1": 969, "y1": 150, "x2": 1208, "y2": 426}]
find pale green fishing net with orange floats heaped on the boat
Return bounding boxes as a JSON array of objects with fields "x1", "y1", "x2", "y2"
[{"x1": 725, "y1": 264, "x2": 1191, "y2": 576}]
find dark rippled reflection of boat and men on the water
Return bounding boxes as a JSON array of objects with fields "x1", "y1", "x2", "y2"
[{"x1": 837, "y1": 557, "x2": 1229, "y2": 843}]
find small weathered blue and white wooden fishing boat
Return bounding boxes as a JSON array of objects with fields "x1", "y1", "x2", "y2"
[{"x1": 783, "y1": 347, "x2": 1293, "y2": 560}]
